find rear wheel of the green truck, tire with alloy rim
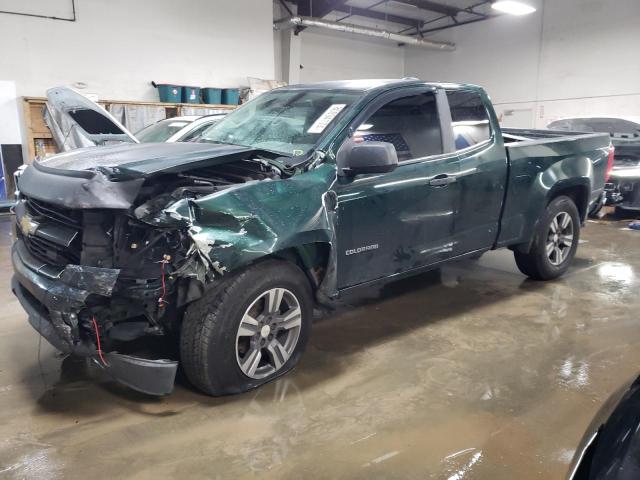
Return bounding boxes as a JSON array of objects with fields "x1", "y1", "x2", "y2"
[{"x1": 514, "y1": 196, "x2": 580, "y2": 280}]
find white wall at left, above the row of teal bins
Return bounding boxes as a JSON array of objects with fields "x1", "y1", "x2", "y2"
[{"x1": 0, "y1": 0, "x2": 274, "y2": 100}]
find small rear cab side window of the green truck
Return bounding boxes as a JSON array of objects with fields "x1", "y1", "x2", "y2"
[{"x1": 447, "y1": 90, "x2": 491, "y2": 150}]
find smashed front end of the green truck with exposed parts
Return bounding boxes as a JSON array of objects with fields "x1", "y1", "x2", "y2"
[{"x1": 12, "y1": 146, "x2": 281, "y2": 395}]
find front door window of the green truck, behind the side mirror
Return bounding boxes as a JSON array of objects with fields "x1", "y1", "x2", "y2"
[{"x1": 353, "y1": 93, "x2": 443, "y2": 162}]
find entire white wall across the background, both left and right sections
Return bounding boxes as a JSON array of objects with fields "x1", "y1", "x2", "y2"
[{"x1": 0, "y1": 0, "x2": 640, "y2": 126}]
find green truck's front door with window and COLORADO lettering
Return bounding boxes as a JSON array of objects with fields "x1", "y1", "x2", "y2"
[{"x1": 334, "y1": 87, "x2": 460, "y2": 288}]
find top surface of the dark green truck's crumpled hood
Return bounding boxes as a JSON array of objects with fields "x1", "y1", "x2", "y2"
[{"x1": 40, "y1": 143, "x2": 258, "y2": 177}]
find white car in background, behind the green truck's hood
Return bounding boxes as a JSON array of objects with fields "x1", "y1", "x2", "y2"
[{"x1": 135, "y1": 113, "x2": 226, "y2": 143}]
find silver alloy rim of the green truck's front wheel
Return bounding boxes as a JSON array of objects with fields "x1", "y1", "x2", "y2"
[{"x1": 236, "y1": 288, "x2": 302, "y2": 379}]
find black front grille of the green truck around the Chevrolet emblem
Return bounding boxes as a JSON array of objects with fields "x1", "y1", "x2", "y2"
[{"x1": 19, "y1": 198, "x2": 82, "y2": 266}]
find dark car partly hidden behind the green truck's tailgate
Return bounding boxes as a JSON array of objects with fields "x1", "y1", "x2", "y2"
[{"x1": 547, "y1": 117, "x2": 640, "y2": 215}]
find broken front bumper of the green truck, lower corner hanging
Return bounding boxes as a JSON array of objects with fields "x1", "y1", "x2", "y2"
[{"x1": 11, "y1": 240, "x2": 178, "y2": 395}]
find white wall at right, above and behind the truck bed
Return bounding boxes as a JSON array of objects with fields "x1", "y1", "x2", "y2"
[{"x1": 405, "y1": 0, "x2": 640, "y2": 127}]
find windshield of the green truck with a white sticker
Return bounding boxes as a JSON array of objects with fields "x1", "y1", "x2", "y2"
[{"x1": 200, "y1": 90, "x2": 361, "y2": 157}]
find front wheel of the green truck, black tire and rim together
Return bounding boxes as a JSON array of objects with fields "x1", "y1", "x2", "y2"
[{"x1": 180, "y1": 260, "x2": 313, "y2": 396}]
